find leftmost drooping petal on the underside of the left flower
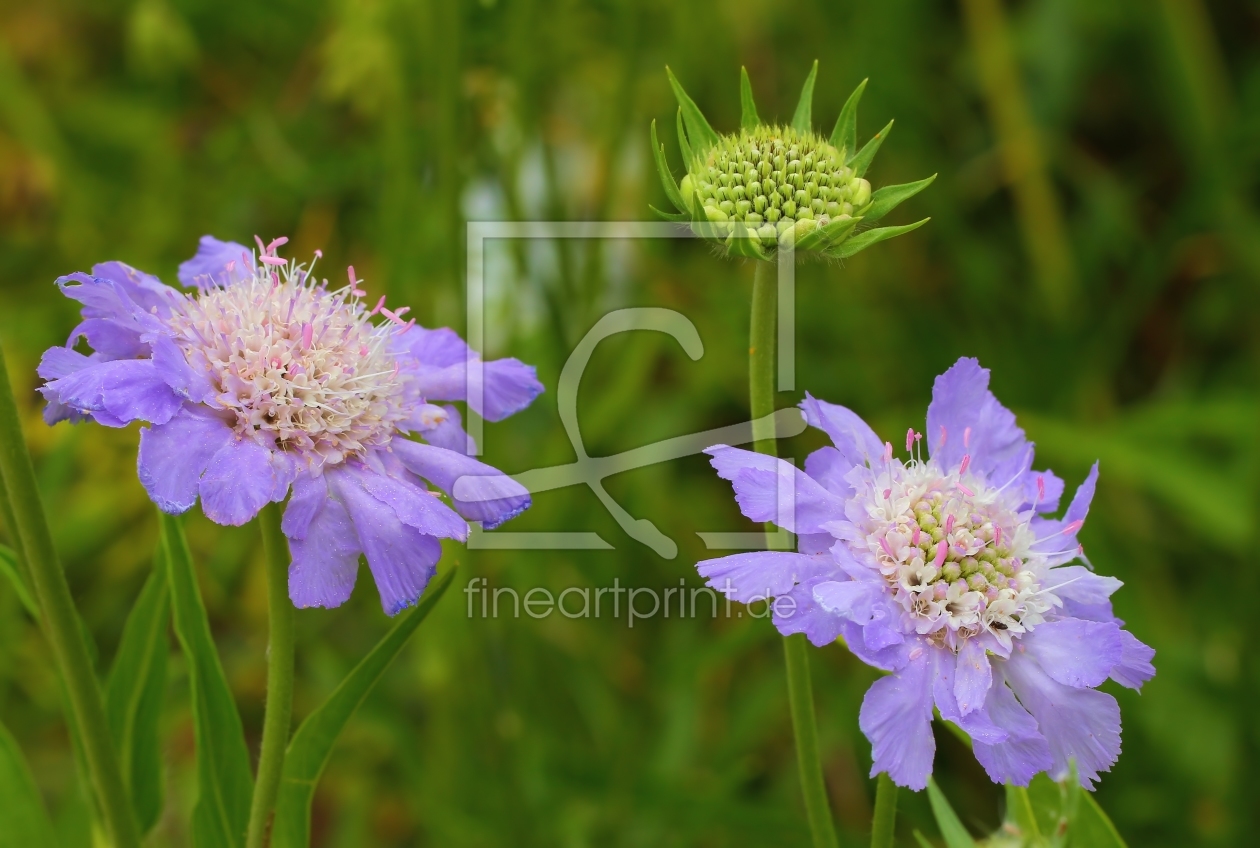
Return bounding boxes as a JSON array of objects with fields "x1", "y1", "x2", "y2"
[{"x1": 136, "y1": 406, "x2": 234, "y2": 514}]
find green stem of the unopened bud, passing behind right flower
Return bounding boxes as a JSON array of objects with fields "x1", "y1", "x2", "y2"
[{"x1": 748, "y1": 262, "x2": 838, "y2": 848}]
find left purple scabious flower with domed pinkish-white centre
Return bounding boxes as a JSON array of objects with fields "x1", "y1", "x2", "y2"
[{"x1": 39, "y1": 236, "x2": 543, "y2": 615}]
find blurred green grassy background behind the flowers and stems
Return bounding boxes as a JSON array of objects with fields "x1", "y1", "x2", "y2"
[{"x1": 0, "y1": 0, "x2": 1260, "y2": 847}]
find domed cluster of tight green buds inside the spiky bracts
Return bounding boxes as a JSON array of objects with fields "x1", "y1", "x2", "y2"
[{"x1": 679, "y1": 125, "x2": 871, "y2": 244}]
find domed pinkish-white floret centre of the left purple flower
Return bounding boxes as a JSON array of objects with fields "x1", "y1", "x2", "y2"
[{"x1": 169, "y1": 255, "x2": 407, "y2": 466}]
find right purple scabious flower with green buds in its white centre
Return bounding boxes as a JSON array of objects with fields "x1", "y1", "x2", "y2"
[{"x1": 698, "y1": 359, "x2": 1155, "y2": 790}]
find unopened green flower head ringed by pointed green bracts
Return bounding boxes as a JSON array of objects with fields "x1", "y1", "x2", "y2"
[{"x1": 651, "y1": 62, "x2": 935, "y2": 258}]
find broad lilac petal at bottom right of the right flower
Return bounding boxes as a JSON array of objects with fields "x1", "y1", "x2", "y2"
[{"x1": 1003, "y1": 650, "x2": 1120, "y2": 789}]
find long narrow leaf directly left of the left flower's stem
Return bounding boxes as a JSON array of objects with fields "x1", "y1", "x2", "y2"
[{"x1": 160, "y1": 513, "x2": 253, "y2": 848}]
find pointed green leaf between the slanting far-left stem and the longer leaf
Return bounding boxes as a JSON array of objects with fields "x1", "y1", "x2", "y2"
[{"x1": 105, "y1": 546, "x2": 170, "y2": 834}]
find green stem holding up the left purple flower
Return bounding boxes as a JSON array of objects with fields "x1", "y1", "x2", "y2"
[{"x1": 246, "y1": 504, "x2": 294, "y2": 848}]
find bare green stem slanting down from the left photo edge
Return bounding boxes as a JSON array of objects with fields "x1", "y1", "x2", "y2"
[{"x1": 0, "y1": 340, "x2": 140, "y2": 848}]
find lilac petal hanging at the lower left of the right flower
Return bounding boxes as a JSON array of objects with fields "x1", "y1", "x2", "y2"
[{"x1": 858, "y1": 651, "x2": 936, "y2": 791}]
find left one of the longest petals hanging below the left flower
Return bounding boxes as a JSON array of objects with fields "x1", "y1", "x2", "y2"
[{"x1": 284, "y1": 476, "x2": 360, "y2": 609}]
